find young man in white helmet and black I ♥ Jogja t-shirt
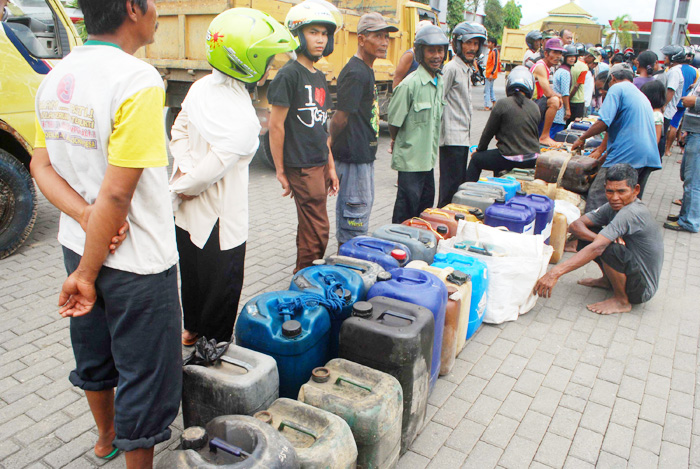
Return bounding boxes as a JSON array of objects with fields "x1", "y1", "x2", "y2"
[{"x1": 267, "y1": 0, "x2": 339, "y2": 273}]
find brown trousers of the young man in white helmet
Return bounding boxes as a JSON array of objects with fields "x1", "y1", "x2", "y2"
[{"x1": 284, "y1": 166, "x2": 330, "y2": 273}]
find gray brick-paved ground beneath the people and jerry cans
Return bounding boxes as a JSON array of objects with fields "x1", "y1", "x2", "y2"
[{"x1": 0, "y1": 78, "x2": 700, "y2": 469}]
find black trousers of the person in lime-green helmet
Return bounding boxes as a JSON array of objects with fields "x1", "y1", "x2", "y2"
[{"x1": 175, "y1": 222, "x2": 246, "y2": 342}]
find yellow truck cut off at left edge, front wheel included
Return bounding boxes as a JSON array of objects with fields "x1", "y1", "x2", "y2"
[{"x1": 0, "y1": 0, "x2": 81, "y2": 259}]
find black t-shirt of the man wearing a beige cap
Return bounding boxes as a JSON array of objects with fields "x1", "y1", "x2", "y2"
[{"x1": 333, "y1": 57, "x2": 379, "y2": 163}]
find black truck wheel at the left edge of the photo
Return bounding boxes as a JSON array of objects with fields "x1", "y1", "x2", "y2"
[{"x1": 0, "y1": 149, "x2": 37, "y2": 259}]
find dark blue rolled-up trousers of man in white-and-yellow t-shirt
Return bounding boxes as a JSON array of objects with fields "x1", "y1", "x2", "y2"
[{"x1": 63, "y1": 248, "x2": 182, "y2": 451}]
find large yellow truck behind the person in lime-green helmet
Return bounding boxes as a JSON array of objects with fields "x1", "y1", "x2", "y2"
[{"x1": 137, "y1": 0, "x2": 438, "y2": 164}]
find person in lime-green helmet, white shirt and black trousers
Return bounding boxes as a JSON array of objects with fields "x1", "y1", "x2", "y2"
[{"x1": 170, "y1": 8, "x2": 297, "y2": 345}]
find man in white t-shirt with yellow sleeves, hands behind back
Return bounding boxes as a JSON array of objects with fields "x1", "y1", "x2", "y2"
[{"x1": 31, "y1": 0, "x2": 182, "y2": 468}]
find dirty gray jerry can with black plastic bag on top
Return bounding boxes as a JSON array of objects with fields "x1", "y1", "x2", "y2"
[{"x1": 182, "y1": 344, "x2": 279, "y2": 428}]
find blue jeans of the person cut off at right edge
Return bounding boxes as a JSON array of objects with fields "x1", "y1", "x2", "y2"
[{"x1": 678, "y1": 133, "x2": 700, "y2": 233}]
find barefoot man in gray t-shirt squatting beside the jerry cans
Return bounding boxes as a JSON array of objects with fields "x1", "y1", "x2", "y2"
[{"x1": 535, "y1": 164, "x2": 664, "y2": 314}]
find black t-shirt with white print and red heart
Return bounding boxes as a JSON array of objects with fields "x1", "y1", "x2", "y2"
[{"x1": 267, "y1": 60, "x2": 331, "y2": 168}]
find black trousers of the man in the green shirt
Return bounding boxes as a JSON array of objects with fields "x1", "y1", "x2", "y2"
[{"x1": 391, "y1": 169, "x2": 435, "y2": 223}]
